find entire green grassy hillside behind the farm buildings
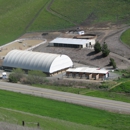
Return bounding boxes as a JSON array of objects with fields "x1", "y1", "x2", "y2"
[{"x1": 0, "y1": 0, "x2": 130, "y2": 45}]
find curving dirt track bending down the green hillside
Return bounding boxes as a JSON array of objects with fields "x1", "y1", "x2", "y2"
[{"x1": 46, "y1": 0, "x2": 77, "y2": 25}]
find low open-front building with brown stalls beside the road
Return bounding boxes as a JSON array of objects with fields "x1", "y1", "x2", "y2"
[{"x1": 66, "y1": 67, "x2": 109, "y2": 80}]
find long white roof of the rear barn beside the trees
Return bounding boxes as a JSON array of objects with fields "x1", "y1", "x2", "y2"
[{"x1": 50, "y1": 38, "x2": 91, "y2": 45}]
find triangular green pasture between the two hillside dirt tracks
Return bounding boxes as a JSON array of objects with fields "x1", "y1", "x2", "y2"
[{"x1": 27, "y1": 9, "x2": 74, "y2": 32}]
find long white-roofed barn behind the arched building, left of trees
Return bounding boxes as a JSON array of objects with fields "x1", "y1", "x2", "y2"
[{"x1": 49, "y1": 38, "x2": 95, "y2": 48}]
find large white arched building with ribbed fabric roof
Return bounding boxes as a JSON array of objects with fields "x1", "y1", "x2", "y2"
[{"x1": 3, "y1": 50, "x2": 73, "y2": 73}]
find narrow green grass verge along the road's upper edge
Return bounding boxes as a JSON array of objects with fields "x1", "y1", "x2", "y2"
[{"x1": 35, "y1": 85, "x2": 130, "y2": 103}]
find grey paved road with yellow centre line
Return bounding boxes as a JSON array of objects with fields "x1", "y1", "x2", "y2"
[{"x1": 0, "y1": 82, "x2": 130, "y2": 114}]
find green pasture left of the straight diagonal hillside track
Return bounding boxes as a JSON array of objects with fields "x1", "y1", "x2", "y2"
[{"x1": 0, "y1": 0, "x2": 47, "y2": 45}]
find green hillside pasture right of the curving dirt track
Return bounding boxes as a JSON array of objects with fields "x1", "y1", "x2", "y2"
[{"x1": 51, "y1": 0, "x2": 130, "y2": 24}]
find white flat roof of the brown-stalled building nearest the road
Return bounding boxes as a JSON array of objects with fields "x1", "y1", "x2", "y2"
[{"x1": 67, "y1": 67, "x2": 109, "y2": 74}]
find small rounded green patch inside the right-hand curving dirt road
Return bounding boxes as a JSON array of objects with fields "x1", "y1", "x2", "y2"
[{"x1": 121, "y1": 29, "x2": 130, "y2": 46}]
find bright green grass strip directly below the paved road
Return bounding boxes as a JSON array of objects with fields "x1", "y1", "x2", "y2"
[{"x1": 0, "y1": 90, "x2": 130, "y2": 130}]
